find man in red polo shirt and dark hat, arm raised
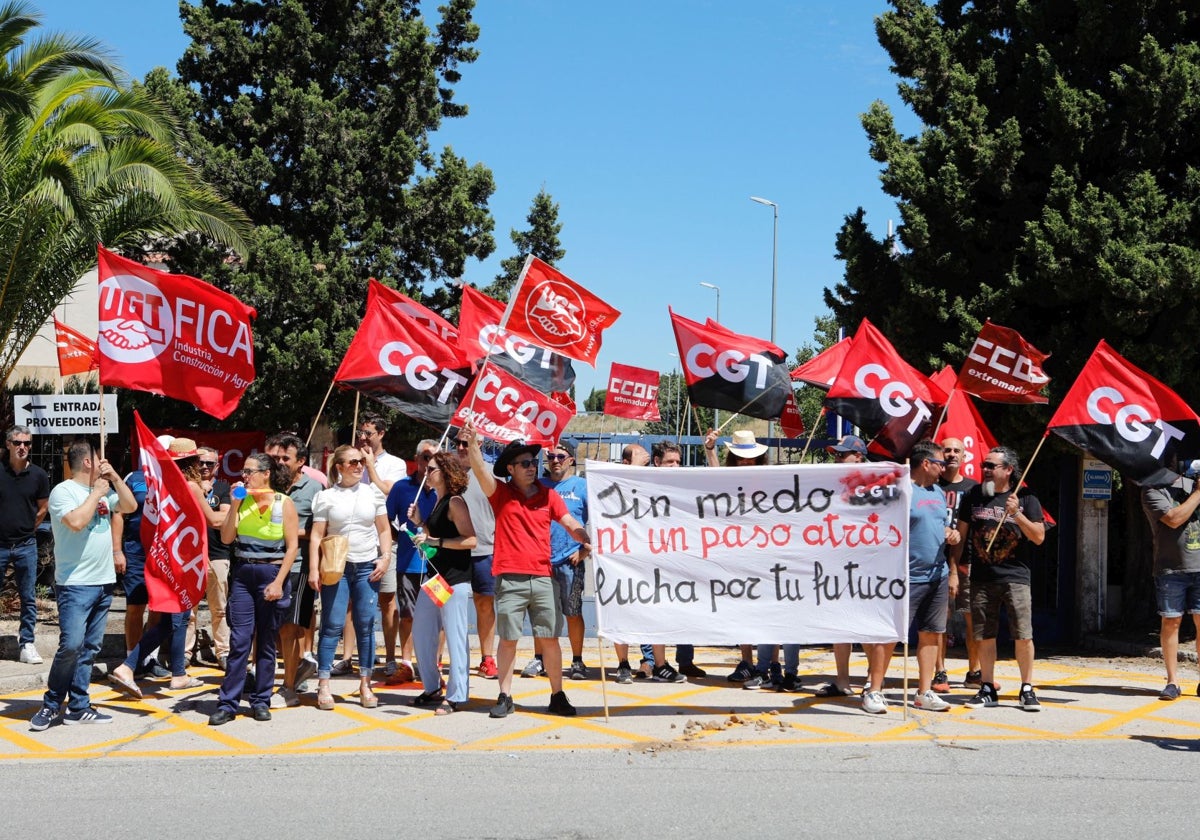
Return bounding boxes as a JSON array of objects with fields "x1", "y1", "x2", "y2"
[{"x1": 458, "y1": 421, "x2": 592, "y2": 718}]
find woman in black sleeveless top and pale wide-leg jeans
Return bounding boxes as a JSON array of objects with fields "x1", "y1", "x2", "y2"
[{"x1": 408, "y1": 452, "x2": 475, "y2": 715}]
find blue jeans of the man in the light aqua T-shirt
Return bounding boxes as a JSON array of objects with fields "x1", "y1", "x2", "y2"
[{"x1": 42, "y1": 583, "x2": 114, "y2": 713}]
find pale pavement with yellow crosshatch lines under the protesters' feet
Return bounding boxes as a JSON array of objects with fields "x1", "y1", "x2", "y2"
[{"x1": 0, "y1": 653, "x2": 1200, "y2": 761}]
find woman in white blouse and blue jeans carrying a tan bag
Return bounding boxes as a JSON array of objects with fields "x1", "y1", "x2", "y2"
[{"x1": 308, "y1": 446, "x2": 391, "y2": 710}]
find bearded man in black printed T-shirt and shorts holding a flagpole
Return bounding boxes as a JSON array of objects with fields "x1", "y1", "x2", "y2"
[{"x1": 959, "y1": 446, "x2": 1046, "y2": 712}]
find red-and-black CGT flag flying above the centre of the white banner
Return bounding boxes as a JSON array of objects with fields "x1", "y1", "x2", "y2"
[{"x1": 667, "y1": 308, "x2": 792, "y2": 420}]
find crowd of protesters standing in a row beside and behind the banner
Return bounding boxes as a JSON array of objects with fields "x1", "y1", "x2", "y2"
[{"x1": 0, "y1": 415, "x2": 1104, "y2": 731}]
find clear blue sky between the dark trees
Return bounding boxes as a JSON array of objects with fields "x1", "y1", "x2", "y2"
[{"x1": 42, "y1": 0, "x2": 916, "y2": 402}]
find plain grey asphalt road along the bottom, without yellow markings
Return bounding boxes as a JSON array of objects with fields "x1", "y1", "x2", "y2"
[{"x1": 0, "y1": 739, "x2": 1185, "y2": 840}]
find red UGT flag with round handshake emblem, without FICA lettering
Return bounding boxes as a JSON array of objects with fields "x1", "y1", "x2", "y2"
[{"x1": 502, "y1": 257, "x2": 620, "y2": 365}]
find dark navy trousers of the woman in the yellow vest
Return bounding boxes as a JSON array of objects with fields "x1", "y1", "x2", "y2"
[{"x1": 220, "y1": 563, "x2": 292, "y2": 714}]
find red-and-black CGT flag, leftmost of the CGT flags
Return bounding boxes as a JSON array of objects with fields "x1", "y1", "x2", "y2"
[{"x1": 334, "y1": 283, "x2": 470, "y2": 426}]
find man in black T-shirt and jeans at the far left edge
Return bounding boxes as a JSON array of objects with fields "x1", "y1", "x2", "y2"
[{"x1": 0, "y1": 426, "x2": 50, "y2": 665}]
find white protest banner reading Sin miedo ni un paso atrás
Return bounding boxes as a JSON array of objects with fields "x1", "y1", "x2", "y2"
[{"x1": 587, "y1": 461, "x2": 912, "y2": 644}]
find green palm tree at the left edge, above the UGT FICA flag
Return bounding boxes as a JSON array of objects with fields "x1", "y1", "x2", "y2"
[{"x1": 0, "y1": 1, "x2": 251, "y2": 382}]
